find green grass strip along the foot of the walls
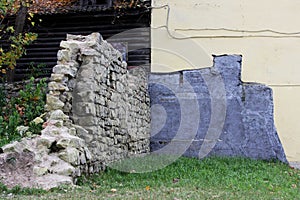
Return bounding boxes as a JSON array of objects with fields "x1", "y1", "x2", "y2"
[{"x1": 0, "y1": 158, "x2": 300, "y2": 200}]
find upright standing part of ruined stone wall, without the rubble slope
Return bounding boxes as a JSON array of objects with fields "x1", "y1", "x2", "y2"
[{"x1": 46, "y1": 33, "x2": 150, "y2": 171}]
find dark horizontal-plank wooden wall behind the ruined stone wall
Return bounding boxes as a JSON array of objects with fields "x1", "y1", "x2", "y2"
[{"x1": 10, "y1": 8, "x2": 151, "y2": 80}]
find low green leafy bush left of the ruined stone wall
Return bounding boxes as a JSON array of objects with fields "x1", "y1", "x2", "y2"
[{"x1": 0, "y1": 77, "x2": 47, "y2": 146}]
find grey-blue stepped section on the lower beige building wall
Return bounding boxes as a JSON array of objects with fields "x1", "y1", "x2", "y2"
[{"x1": 149, "y1": 55, "x2": 287, "y2": 162}]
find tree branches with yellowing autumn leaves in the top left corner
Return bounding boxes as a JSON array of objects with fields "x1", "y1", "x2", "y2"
[{"x1": 0, "y1": 0, "x2": 75, "y2": 79}]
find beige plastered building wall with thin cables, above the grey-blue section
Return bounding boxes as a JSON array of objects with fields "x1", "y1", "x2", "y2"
[{"x1": 151, "y1": 0, "x2": 300, "y2": 161}]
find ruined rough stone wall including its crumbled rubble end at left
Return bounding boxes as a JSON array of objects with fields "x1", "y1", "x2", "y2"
[{"x1": 0, "y1": 33, "x2": 150, "y2": 189}]
